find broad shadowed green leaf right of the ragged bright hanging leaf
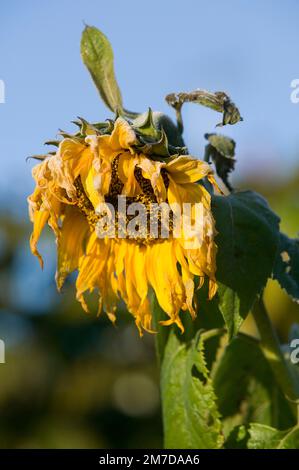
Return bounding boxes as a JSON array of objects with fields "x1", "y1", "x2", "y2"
[{"x1": 211, "y1": 334, "x2": 295, "y2": 436}]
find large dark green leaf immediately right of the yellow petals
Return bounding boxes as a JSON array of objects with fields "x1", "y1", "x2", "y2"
[{"x1": 212, "y1": 191, "x2": 279, "y2": 338}]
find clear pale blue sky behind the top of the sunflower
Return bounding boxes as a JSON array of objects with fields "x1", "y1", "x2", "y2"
[{"x1": 0, "y1": 0, "x2": 299, "y2": 210}]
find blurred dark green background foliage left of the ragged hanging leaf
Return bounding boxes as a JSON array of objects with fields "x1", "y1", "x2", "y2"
[{"x1": 0, "y1": 217, "x2": 162, "y2": 448}]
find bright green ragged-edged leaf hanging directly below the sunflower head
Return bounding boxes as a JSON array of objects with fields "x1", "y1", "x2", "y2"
[{"x1": 161, "y1": 329, "x2": 223, "y2": 449}]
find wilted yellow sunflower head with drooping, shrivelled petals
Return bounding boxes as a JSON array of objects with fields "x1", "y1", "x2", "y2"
[{"x1": 28, "y1": 117, "x2": 217, "y2": 334}]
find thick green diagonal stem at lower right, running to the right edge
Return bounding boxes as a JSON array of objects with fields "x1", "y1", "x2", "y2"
[{"x1": 252, "y1": 297, "x2": 299, "y2": 408}]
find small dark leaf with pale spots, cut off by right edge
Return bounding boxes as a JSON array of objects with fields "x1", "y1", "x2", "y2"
[{"x1": 273, "y1": 233, "x2": 299, "y2": 302}]
